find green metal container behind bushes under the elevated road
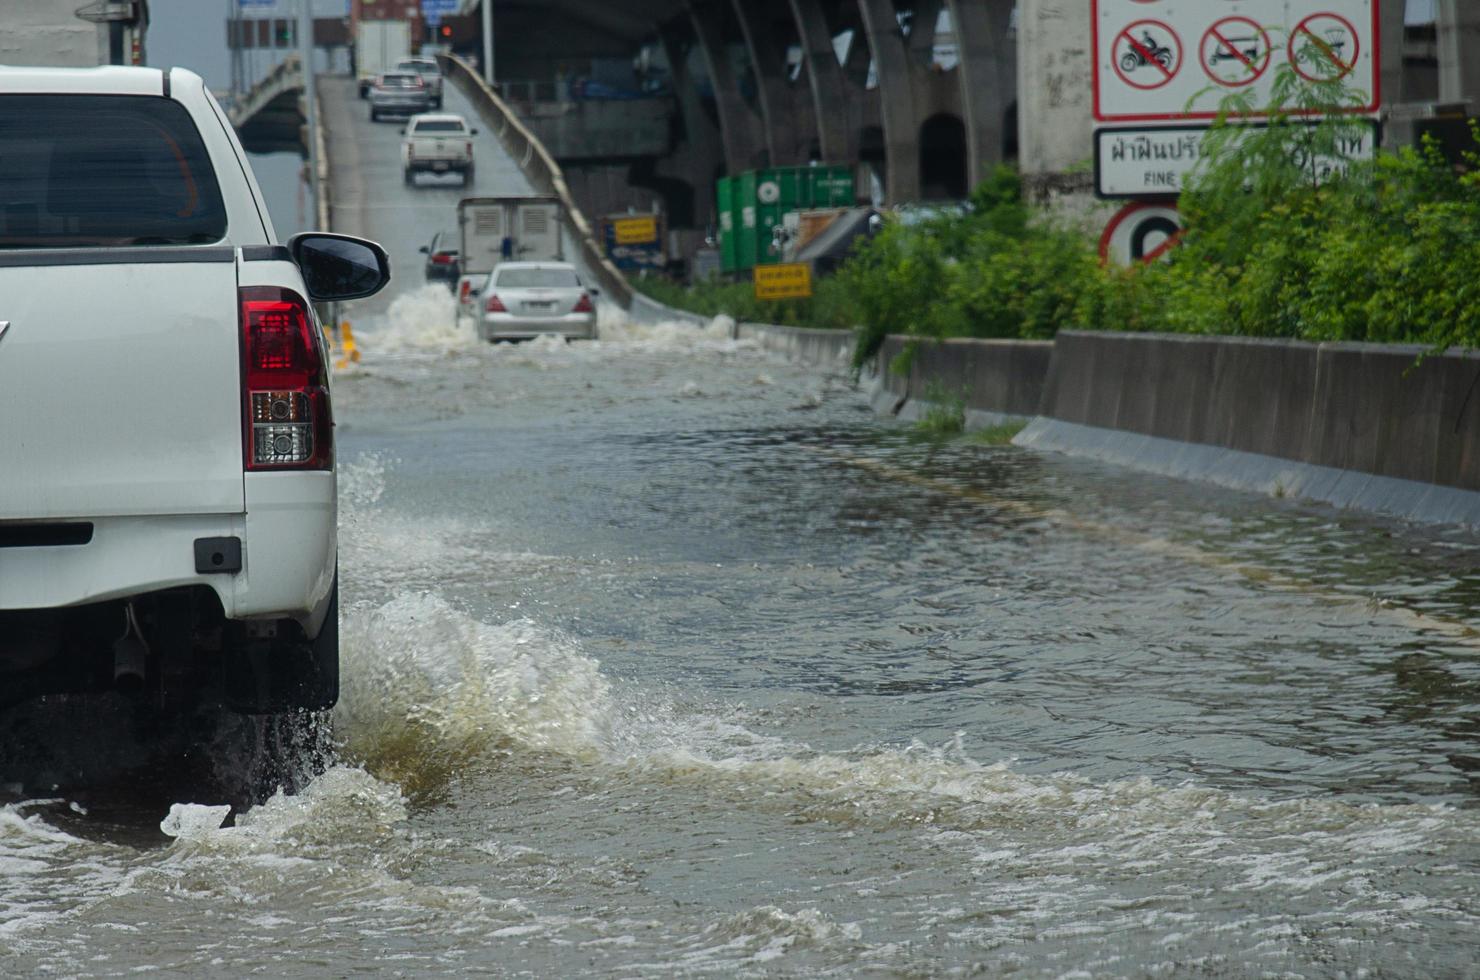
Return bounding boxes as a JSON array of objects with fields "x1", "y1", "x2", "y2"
[{"x1": 715, "y1": 166, "x2": 854, "y2": 272}]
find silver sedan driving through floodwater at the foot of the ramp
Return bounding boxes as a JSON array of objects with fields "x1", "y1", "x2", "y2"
[{"x1": 478, "y1": 262, "x2": 598, "y2": 342}]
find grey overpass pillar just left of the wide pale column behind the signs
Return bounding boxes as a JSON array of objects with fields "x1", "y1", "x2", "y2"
[{"x1": 950, "y1": 0, "x2": 1017, "y2": 187}]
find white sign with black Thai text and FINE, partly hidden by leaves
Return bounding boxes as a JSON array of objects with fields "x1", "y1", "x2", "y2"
[{"x1": 1095, "y1": 120, "x2": 1378, "y2": 198}]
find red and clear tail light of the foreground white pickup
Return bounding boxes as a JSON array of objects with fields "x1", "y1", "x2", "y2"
[{"x1": 238, "y1": 286, "x2": 334, "y2": 471}]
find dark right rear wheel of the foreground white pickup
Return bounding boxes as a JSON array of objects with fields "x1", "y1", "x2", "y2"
[{"x1": 222, "y1": 574, "x2": 339, "y2": 715}]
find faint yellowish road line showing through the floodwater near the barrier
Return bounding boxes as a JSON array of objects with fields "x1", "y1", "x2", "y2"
[{"x1": 802, "y1": 446, "x2": 1480, "y2": 647}]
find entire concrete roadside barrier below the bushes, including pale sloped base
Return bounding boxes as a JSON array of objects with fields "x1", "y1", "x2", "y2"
[{"x1": 740, "y1": 324, "x2": 1480, "y2": 526}]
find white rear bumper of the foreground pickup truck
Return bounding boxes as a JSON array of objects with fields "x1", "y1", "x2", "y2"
[{"x1": 0, "y1": 472, "x2": 337, "y2": 637}]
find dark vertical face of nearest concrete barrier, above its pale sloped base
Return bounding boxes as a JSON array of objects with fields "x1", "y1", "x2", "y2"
[{"x1": 1040, "y1": 330, "x2": 1480, "y2": 490}]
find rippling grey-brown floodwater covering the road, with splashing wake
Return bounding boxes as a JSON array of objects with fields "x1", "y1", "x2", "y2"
[{"x1": 0, "y1": 289, "x2": 1480, "y2": 977}]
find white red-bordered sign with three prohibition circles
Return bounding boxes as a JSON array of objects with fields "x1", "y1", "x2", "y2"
[{"x1": 1091, "y1": 0, "x2": 1379, "y2": 123}]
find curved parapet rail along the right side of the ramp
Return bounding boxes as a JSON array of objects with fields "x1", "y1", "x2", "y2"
[{"x1": 437, "y1": 55, "x2": 632, "y2": 309}]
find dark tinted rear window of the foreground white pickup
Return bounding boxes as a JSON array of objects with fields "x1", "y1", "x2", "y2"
[{"x1": 0, "y1": 95, "x2": 226, "y2": 249}]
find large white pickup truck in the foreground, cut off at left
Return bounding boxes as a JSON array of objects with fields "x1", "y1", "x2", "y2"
[{"x1": 0, "y1": 68, "x2": 389, "y2": 714}]
